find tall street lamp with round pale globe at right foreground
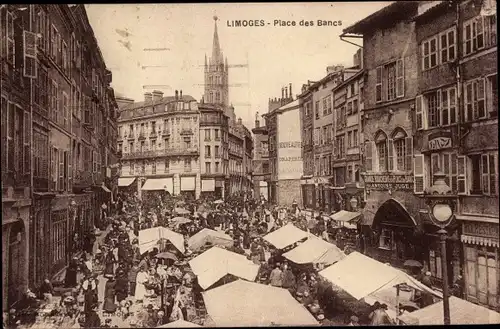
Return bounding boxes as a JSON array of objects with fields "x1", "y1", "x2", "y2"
[{"x1": 424, "y1": 171, "x2": 456, "y2": 325}]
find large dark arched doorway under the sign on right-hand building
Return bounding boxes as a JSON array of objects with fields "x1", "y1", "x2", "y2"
[{"x1": 372, "y1": 199, "x2": 425, "y2": 266}]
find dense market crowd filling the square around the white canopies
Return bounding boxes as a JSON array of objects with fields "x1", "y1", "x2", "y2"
[{"x1": 4, "y1": 188, "x2": 428, "y2": 328}]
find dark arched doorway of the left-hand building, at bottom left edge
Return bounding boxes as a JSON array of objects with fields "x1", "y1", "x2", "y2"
[{"x1": 7, "y1": 221, "x2": 26, "y2": 308}]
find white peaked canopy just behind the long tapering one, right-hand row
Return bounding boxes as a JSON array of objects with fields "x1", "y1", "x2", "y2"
[{"x1": 283, "y1": 236, "x2": 345, "y2": 265}]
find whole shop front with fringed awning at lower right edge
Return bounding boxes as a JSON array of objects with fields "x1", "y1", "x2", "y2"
[{"x1": 457, "y1": 216, "x2": 500, "y2": 311}]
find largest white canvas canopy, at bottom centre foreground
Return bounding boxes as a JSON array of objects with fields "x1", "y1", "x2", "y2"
[{"x1": 202, "y1": 280, "x2": 318, "y2": 327}]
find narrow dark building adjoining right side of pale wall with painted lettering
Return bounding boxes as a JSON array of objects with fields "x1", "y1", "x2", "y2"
[{"x1": 297, "y1": 81, "x2": 316, "y2": 209}]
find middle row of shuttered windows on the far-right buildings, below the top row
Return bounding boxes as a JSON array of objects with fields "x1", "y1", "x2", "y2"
[{"x1": 415, "y1": 73, "x2": 498, "y2": 129}]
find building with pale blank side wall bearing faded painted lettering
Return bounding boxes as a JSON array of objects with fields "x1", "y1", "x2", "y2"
[{"x1": 263, "y1": 86, "x2": 303, "y2": 206}]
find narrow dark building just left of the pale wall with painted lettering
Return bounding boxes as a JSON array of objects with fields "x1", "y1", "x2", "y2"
[{"x1": 252, "y1": 113, "x2": 270, "y2": 200}]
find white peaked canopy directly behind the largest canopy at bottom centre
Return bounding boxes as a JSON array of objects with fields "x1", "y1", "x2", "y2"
[{"x1": 189, "y1": 247, "x2": 260, "y2": 289}]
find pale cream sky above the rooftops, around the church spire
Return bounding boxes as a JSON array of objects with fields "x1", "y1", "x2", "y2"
[{"x1": 85, "y1": 2, "x2": 390, "y2": 129}]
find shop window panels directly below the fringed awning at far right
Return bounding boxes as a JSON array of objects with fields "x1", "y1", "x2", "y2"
[{"x1": 465, "y1": 246, "x2": 500, "y2": 308}]
